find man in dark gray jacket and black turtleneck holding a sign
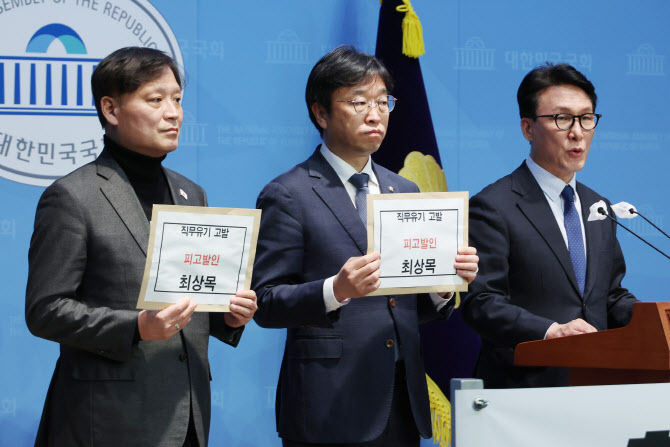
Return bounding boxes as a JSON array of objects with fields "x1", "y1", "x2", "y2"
[{"x1": 26, "y1": 47, "x2": 256, "y2": 447}]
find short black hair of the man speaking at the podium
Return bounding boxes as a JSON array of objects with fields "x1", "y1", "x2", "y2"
[{"x1": 516, "y1": 62, "x2": 598, "y2": 118}]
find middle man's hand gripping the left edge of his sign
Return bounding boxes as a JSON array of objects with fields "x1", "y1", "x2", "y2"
[{"x1": 333, "y1": 251, "x2": 382, "y2": 303}]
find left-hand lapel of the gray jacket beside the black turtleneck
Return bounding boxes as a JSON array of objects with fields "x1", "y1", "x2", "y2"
[{"x1": 96, "y1": 151, "x2": 149, "y2": 255}]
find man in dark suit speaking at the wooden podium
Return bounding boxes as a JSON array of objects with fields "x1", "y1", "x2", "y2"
[{"x1": 462, "y1": 64, "x2": 635, "y2": 388}]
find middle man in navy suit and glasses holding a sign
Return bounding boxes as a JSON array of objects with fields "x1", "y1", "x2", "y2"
[{"x1": 252, "y1": 47, "x2": 477, "y2": 447}]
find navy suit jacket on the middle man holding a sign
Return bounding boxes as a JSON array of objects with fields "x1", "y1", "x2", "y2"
[{"x1": 252, "y1": 148, "x2": 450, "y2": 443}]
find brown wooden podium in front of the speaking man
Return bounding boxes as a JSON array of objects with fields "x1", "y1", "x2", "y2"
[{"x1": 514, "y1": 302, "x2": 670, "y2": 386}]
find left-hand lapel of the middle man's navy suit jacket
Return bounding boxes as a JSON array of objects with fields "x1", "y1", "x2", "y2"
[{"x1": 308, "y1": 147, "x2": 368, "y2": 254}]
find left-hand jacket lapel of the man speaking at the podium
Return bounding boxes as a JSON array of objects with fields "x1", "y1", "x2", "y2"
[{"x1": 512, "y1": 162, "x2": 581, "y2": 295}]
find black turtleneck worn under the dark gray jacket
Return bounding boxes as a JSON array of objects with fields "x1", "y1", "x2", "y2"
[{"x1": 105, "y1": 135, "x2": 173, "y2": 220}]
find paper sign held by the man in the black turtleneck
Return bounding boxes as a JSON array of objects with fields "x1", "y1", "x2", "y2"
[{"x1": 137, "y1": 205, "x2": 260, "y2": 312}]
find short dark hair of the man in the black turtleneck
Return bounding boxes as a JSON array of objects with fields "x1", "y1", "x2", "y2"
[{"x1": 91, "y1": 47, "x2": 183, "y2": 127}]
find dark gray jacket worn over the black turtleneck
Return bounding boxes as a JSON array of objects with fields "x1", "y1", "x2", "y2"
[{"x1": 26, "y1": 150, "x2": 241, "y2": 447}]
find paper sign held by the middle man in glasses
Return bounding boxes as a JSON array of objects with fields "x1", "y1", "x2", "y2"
[{"x1": 368, "y1": 192, "x2": 468, "y2": 295}]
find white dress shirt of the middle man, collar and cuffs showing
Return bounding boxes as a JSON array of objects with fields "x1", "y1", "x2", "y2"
[{"x1": 321, "y1": 143, "x2": 453, "y2": 312}]
